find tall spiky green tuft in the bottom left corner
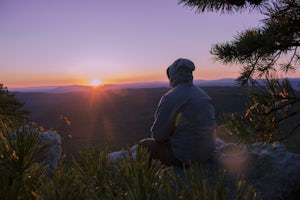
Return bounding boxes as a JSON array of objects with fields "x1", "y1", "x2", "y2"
[{"x1": 0, "y1": 126, "x2": 46, "y2": 199}]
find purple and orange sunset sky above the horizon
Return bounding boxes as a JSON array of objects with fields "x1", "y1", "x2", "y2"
[{"x1": 0, "y1": 0, "x2": 300, "y2": 88}]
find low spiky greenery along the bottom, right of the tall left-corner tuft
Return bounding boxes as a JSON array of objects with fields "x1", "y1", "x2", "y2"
[{"x1": 36, "y1": 146, "x2": 258, "y2": 200}]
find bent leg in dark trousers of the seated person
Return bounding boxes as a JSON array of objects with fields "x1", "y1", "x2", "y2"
[{"x1": 138, "y1": 138, "x2": 182, "y2": 167}]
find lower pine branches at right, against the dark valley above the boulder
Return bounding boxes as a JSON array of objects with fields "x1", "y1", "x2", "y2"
[{"x1": 224, "y1": 79, "x2": 300, "y2": 144}]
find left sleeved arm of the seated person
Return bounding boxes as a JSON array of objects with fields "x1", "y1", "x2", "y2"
[{"x1": 151, "y1": 96, "x2": 176, "y2": 142}]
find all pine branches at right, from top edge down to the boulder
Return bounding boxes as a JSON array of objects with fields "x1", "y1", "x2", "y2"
[{"x1": 179, "y1": 0, "x2": 300, "y2": 143}]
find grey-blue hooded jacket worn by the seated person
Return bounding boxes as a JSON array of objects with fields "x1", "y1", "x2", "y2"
[{"x1": 151, "y1": 58, "x2": 217, "y2": 163}]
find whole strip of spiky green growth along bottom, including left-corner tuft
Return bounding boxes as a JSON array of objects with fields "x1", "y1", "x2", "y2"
[{"x1": 0, "y1": 125, "x2": 258, "y2": 200}]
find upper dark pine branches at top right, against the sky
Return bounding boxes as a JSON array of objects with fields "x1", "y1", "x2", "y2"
[{"x1": 180, "y1": 0, "x2": 300, "y2": 84}]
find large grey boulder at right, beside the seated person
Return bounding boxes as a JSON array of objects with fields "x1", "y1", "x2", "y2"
[{"x1": 204, "y1": 143, "x2": 300, "y2": 200}]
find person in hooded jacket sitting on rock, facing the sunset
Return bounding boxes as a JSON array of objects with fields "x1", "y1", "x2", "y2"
[{"x1": 138, "y1": 58, "x2": 217, "y2": 167}]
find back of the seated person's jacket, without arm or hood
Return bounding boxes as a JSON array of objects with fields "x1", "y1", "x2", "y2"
[{"x1": 168, "y1": 84, "x2": 216, "y2": 162}]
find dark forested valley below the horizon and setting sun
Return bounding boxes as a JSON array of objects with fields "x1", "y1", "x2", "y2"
[{"x1": 13, "y1": 87, "x2": 246, "y2": 153}]
